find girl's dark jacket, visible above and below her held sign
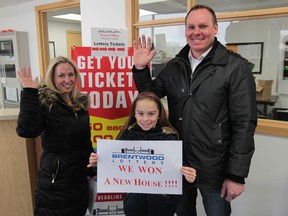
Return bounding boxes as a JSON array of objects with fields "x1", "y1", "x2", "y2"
[{"x1": 120, "y1": 124, "x2": 178, "y2": 216}]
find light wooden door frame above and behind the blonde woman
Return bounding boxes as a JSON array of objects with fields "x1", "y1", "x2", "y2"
[{"x1": 35, "y1": 0, "x2": 80, "y2": 78}]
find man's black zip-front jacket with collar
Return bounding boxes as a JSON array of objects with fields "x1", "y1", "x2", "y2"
[{"x1": 133, "y1": 38, "x2": 257, "y2": 187}]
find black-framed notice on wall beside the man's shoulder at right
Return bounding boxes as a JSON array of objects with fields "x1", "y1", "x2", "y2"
[{"x1": 226, "y1": 42, "x2": 264, "y2": 74}]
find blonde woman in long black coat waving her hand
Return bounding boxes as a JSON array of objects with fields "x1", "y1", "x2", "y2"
[{"x1": 16, "y1": 57, "x2": 94, "y2": 216}]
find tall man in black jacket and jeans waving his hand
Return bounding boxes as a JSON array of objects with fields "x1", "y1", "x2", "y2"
[{"x1": 133, "y1": 5, "x2": 257, "y2": 216}]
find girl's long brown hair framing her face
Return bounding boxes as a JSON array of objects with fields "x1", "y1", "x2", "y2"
[{"x1": 116, "y1": 92, "x2": 178, "y2": 140}]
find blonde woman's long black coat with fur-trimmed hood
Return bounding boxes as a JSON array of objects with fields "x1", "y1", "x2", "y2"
[{"x1": 16, "y1": 87, "x2": 94, "y2": 216}]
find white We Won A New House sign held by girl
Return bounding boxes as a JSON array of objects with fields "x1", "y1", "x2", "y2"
[{"x1": 97, "y1": 140, "x2": 182, "y2": 194}]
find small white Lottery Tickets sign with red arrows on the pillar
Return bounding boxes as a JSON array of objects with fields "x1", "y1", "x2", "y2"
[{"x1": 91, "y1": 28, "x2": 128, "y2": 57}]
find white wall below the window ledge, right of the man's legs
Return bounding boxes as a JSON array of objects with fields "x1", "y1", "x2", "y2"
[{"x1": 197, "y1": 134, "x2": 288, "y2": 216}]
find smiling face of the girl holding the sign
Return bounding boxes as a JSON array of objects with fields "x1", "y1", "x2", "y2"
[{"x1": 135, "y1": 99, "x2": 159, "y2": 131}]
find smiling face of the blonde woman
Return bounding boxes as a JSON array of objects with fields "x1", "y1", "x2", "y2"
[{"x1": 54, "y1": 63, "x2": 76, "y2": 94}]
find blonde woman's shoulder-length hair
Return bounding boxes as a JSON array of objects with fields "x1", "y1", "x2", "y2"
[{"x1": 45, "y1": 56, "x2": 88, "y2": 109}]
